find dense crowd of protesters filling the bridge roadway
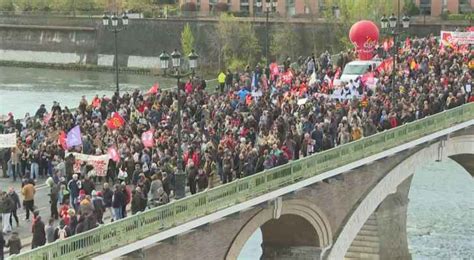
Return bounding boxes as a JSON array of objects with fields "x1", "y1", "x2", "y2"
[{"x1": 0, "y1": 34, "x2": 474, "y2": 254}]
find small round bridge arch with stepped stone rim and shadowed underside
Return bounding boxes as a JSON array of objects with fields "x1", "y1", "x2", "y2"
[{"x1": 225, "y1": 199, "x2": 333, "y2": 259}]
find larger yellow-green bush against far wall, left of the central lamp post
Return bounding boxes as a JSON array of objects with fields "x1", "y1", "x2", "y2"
[{"x1": 215, "y1": 13, "x2": 260, "y2": 67}]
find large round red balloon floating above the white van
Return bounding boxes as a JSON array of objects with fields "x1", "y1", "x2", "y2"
[{"x1": 349, "y1": 20, "x2": 379, "y2": 60}]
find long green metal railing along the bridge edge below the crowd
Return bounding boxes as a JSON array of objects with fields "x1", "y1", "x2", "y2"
[{"x1": 11, "y1": 103, "x2": 474, "y2": 259}]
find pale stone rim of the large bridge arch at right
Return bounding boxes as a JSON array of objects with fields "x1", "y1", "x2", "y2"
[{"x1": 327, "y1": 134, "x2": 474, "y2": 260}]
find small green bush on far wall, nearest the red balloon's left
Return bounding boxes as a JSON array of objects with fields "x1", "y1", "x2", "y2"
[{"x1": 270, "y1": 22, "x2": 301, "y2": 61}]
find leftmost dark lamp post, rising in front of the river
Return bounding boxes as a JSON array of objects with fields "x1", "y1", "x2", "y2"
[{"x1": 102, "y1": 13, "x2": 128, "y2": 95}]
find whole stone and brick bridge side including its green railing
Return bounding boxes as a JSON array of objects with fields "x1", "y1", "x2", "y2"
[{"x1": 11, "y1": 103, "x2": 474, "y2": 260}]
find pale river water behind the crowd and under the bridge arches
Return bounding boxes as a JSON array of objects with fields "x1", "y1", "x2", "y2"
[{"x1": 0, "y1": 67, "x2": 474, "y2": 260}]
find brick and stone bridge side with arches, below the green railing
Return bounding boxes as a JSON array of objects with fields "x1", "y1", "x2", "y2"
[{"x1": 121, "y1": 127, "x2": 474, "y2": 259}]
